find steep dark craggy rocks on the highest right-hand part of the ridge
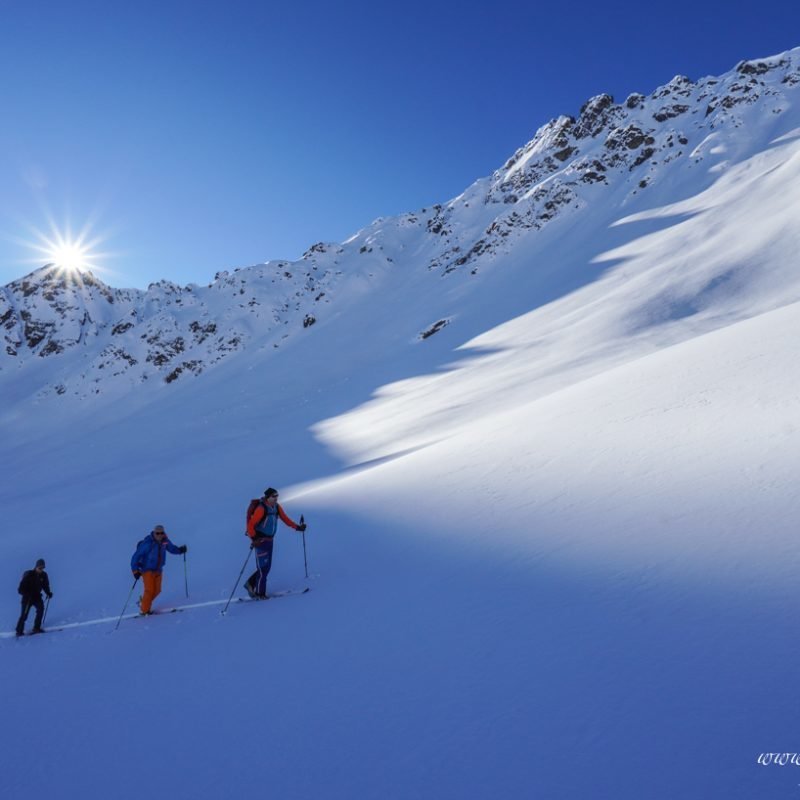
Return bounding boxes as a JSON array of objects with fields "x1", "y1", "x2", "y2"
[{"x1": 418, "y1": 50, "x2": 800, "y2": 275}]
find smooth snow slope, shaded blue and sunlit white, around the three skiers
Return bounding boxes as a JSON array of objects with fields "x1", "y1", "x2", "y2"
[{"x1": 0, "y1": 51, "x2": 800, "y2": 800}]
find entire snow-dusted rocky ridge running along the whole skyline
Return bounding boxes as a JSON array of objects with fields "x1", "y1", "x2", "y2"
[{"x1": 0, "y1": 49, "x2": 800, "y2": 396}]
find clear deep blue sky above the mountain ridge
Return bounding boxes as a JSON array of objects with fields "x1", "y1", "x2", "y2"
[{"x1": 0, "y1": 0, "x2": 800, "y2": 288}]
